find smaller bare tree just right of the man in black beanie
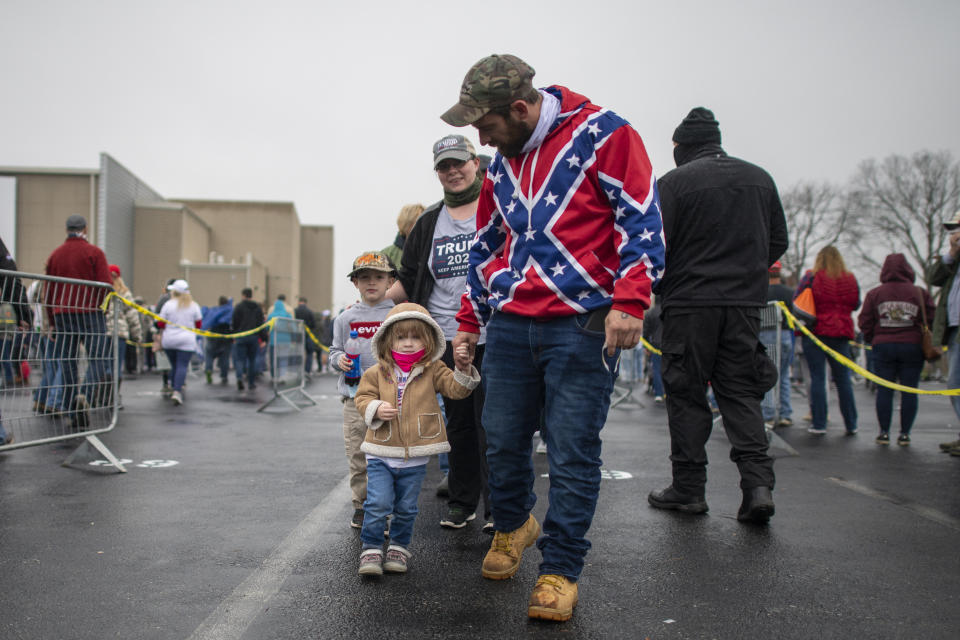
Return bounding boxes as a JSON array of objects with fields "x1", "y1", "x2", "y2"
[{"x1": 780, "y1": 182, "x2": 848, "y2": 279}]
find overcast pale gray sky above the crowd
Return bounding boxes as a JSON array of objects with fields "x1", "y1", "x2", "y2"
[{"x1": 0, "y1": 0, "x2": 960, "y2": 304}]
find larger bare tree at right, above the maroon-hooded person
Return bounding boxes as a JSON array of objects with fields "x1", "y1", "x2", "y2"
[{"x1": 845, "y1": 151, "x2": 960, "y2": 288}]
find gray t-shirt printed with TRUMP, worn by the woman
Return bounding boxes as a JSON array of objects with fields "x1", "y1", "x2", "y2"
[{"x1": 427, "y1": 205, "x2": 486, "y2": 343}]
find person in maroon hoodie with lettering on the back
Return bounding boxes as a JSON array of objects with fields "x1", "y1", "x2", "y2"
[{"x1": 857, "y1": 253, "x2": 936, "y2": 447}]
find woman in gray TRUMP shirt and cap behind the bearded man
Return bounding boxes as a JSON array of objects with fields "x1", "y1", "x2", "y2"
[{"x1": 387, "y1": 135, "x2": 492, "y2": 533}]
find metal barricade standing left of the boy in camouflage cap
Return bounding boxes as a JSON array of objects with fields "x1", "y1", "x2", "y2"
[{"x1": 257, "y1": 317, "x2": 317, "y2": 412}]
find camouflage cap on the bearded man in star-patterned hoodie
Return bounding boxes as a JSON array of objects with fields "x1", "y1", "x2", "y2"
[{"x1": 440, "y1": 54, "x2": 536, "y2": 127}]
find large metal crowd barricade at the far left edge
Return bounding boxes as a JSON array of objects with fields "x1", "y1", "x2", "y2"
[{"x1": 0, "y1": 270, "x2": 126, "y2": 472}]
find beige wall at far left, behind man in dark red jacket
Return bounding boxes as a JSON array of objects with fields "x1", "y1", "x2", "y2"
[{"x1": 0, "y1": 169, "x2": 98, "y2": 273}]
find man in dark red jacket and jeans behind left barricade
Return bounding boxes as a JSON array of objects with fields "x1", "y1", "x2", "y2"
[{"x1": 44, "y1": 215, "x2": 113, "y2": 427}]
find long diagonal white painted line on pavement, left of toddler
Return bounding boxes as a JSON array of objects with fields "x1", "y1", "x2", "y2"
[{"x1": 188, "y1": 475, "x2": 350, "y2": 640}]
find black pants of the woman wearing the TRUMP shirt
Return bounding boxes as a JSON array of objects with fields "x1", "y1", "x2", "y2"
[{"x1": 443, "y1": 342, "x2": 490, "y2": 518}]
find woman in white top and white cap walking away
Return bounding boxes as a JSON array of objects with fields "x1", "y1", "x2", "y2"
[{"x1": 158, "y1": 280, "x2": 203, "y2": 404}]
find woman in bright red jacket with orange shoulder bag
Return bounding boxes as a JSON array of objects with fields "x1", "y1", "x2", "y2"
[{"x1": 797, "y1": 245, "x2": 860, "y2": 435}]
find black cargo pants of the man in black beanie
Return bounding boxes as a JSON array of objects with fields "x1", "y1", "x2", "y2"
[{"x1": 662, "y1": 307, "x2": 777, "y2": 495}]
